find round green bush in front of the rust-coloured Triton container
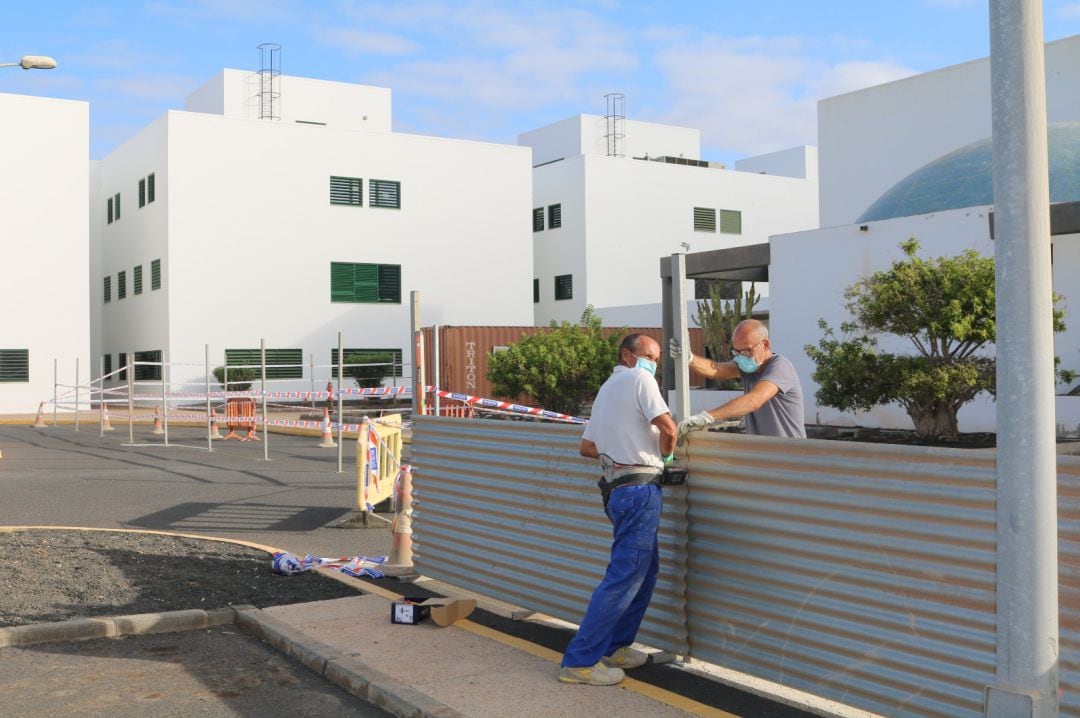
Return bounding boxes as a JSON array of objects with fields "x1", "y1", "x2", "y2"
[{"x1": 487, "y1": 306, "x2": 622, "y2": 416}]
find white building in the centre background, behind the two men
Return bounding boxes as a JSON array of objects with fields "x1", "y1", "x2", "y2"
[{"x1": 517, "y1": 114, "x2": 819, "y2": 326}]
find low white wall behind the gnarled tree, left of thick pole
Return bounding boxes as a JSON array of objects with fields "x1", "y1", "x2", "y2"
[{"x1": 769, "y1": 207, "x2": 994, "y2": 431}]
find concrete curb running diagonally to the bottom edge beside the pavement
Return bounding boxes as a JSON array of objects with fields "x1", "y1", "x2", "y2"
[{"x1": 237, "y1": 608, "x2": 465, "y2": 718}]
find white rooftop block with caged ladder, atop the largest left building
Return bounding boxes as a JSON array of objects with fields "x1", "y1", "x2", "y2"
[{"x1": 184, "y1": 69, "x2": 391, "y2": 132}]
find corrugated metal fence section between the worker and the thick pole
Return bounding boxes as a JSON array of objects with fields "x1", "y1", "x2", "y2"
[{"x1": 688, "y1": 433, "x2": 996, "y2": 718}]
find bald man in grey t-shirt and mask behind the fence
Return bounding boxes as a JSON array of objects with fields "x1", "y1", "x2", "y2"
[{"x1": 669, "y1": 320, "x2": 807, "y2": 442}]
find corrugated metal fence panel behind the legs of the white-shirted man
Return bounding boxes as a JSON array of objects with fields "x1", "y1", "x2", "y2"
[{"x1": 413, "y1": 417, "x2": 687, "y2": 654}]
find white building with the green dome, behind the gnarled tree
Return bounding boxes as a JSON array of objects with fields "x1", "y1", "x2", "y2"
[{"x1": 769, "y1": 37, "x2": 1080, "y2": 434}]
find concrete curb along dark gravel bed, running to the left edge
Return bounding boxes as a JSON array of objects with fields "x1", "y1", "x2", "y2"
[{"x1": 0, "y1": 607, "x2": 238, "y2": 648}]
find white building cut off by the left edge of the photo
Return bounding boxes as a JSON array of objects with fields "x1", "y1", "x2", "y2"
[{"x1": 0, "y1": 94, "x2": 91, "y2": 414}]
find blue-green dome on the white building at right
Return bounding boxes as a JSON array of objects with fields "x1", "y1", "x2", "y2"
[{"x1": 855, "y1": 122, "x2": 1080, "y2": 223}]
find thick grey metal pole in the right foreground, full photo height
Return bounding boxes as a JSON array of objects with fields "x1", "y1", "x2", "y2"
[{"x1": 985, "y1": 0, "x2": 1058, "y2": 718}]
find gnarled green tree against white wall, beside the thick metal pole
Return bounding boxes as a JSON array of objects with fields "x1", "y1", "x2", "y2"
[{"x1": 806, "y1": 239, "x2": 1072, "y2": 439}]
